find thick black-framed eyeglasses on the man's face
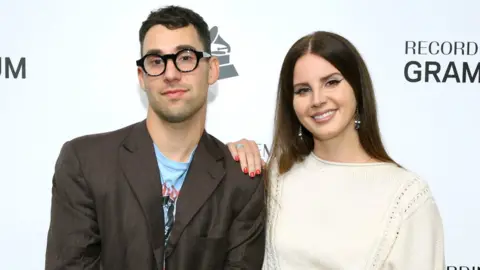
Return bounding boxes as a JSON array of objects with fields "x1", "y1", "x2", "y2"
[{"x1": 137, "y1": 49, "x2": 211, "y2": 76}]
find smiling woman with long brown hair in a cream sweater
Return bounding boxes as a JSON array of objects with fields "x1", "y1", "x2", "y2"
[{"x1": 228, "y1": 32, "x2": 444, "y2": 270}]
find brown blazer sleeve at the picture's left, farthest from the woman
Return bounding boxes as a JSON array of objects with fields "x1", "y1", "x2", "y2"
[{"x1": 45, "y1": 142, "x2": 100, "y2": 270}]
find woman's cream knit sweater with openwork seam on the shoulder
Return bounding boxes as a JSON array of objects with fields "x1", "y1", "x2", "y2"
[{"x1": 263, "y1": 154, "x2": 445, "y2": 270}]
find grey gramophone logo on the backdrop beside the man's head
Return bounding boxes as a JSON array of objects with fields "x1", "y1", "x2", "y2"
[{"x1": 210, "y1": 26, "x2": 238, "y2": 80}]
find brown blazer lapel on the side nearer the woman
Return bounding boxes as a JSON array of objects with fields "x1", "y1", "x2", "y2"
[{"x1": 165, "y1": 132, "x2": 225, "y2": 257}]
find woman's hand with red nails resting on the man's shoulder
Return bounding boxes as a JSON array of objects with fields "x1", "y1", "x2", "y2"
[{"x1": 227, "y1": 139, "x2": 265, "y2": 177}]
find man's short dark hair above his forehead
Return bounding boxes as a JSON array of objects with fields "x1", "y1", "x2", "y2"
[{"x1": 139, "y1": 6, "x2": 211, "y2": 53}]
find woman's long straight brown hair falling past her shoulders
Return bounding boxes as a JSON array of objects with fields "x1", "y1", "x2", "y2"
[{"x1": 267, "y1": 31, "x2": 398, "y2": 179}]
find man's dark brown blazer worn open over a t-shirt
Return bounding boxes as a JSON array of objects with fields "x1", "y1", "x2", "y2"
[{"x1": 45, "y1": 121, "x2": 265, "y2": 270}]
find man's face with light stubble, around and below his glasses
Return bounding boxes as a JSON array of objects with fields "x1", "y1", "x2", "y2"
[{"x1": 138, "y1": 25, "x2": 219, "y2": 123}]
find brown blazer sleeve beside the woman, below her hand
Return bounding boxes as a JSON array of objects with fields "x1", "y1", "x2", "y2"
[{"x1": 225, "y1": 176, "x2": 265, "y2": 270}]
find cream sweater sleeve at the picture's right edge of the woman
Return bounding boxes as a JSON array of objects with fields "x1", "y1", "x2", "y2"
[{"x1": 385, "y1": 197, "x2": 445, "y2": 270}]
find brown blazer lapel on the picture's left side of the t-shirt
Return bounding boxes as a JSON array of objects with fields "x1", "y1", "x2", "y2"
[{"x1": 119, "y1": 121, "x2": 165, "y2": 269}]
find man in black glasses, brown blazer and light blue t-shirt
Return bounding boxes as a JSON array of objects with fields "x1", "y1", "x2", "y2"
[{"x1": 46, "y1": 6, "x2": 265, "y2": 270}]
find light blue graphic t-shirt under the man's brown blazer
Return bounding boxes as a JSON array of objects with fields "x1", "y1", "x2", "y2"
[{"x1": 154, "y1": 144, "x2": 195, "y2": 243}]
